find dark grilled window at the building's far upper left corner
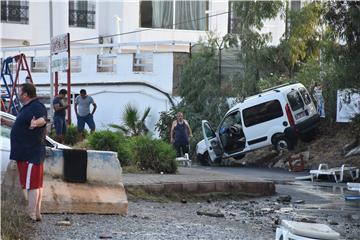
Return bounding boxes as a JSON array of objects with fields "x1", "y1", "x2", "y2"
[{"x1": 1, "y1": 1, "x2": 29, "y2": 24}]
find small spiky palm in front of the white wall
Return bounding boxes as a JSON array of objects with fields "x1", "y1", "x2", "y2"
[{"x1": 109, "y1": 104, "x2": 151, "y2": 136}]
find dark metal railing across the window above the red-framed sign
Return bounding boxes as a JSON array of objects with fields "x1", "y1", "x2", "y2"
[{"x1": 69, "y1": 9, "x2": 95, "y2": 28}]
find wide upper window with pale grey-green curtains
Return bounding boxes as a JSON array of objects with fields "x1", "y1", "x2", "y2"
[{"x1": 140, "y1": 0, "x2": 209, "y2": 31}]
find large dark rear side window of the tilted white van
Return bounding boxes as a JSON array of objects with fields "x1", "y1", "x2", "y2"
[{"x1": 243, "y1": 100, "x2": 284, "y2": 127}]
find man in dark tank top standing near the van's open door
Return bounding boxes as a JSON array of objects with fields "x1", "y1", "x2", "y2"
[{"x1": 170, "y1": 112, "x2": 192, "y2": 157}]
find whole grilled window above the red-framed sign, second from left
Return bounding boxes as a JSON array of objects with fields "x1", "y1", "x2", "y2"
[{"x1": 69, "y1": 1, "x2": 96, "y2": 28}]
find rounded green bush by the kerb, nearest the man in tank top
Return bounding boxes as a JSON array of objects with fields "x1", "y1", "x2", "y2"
[{"x1": 129, "y1": 136, "x2": 177, "y2": 173}]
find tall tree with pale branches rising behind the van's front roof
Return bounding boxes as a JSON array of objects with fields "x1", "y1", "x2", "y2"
[{"x1": 231, "y1": 1, "x2": 283, "y2": 95}]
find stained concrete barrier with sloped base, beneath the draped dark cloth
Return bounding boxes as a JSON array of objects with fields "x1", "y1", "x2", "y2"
[{"x1": 42, "y1": 149, "x2": 128, "y2": 215}]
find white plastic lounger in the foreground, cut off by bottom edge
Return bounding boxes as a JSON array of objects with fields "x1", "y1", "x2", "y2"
[{"x1": 276, "y1": 220, "x2": 340, "y2": 240}]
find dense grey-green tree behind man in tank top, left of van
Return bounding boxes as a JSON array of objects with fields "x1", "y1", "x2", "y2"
[{"x1": 178, "y1": 40, "x2": 226, "y2": 124}]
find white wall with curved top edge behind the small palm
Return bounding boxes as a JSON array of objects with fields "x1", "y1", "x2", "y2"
[{"x1": 37, "y1": 85, "x2": 171, "y2": 137}]
